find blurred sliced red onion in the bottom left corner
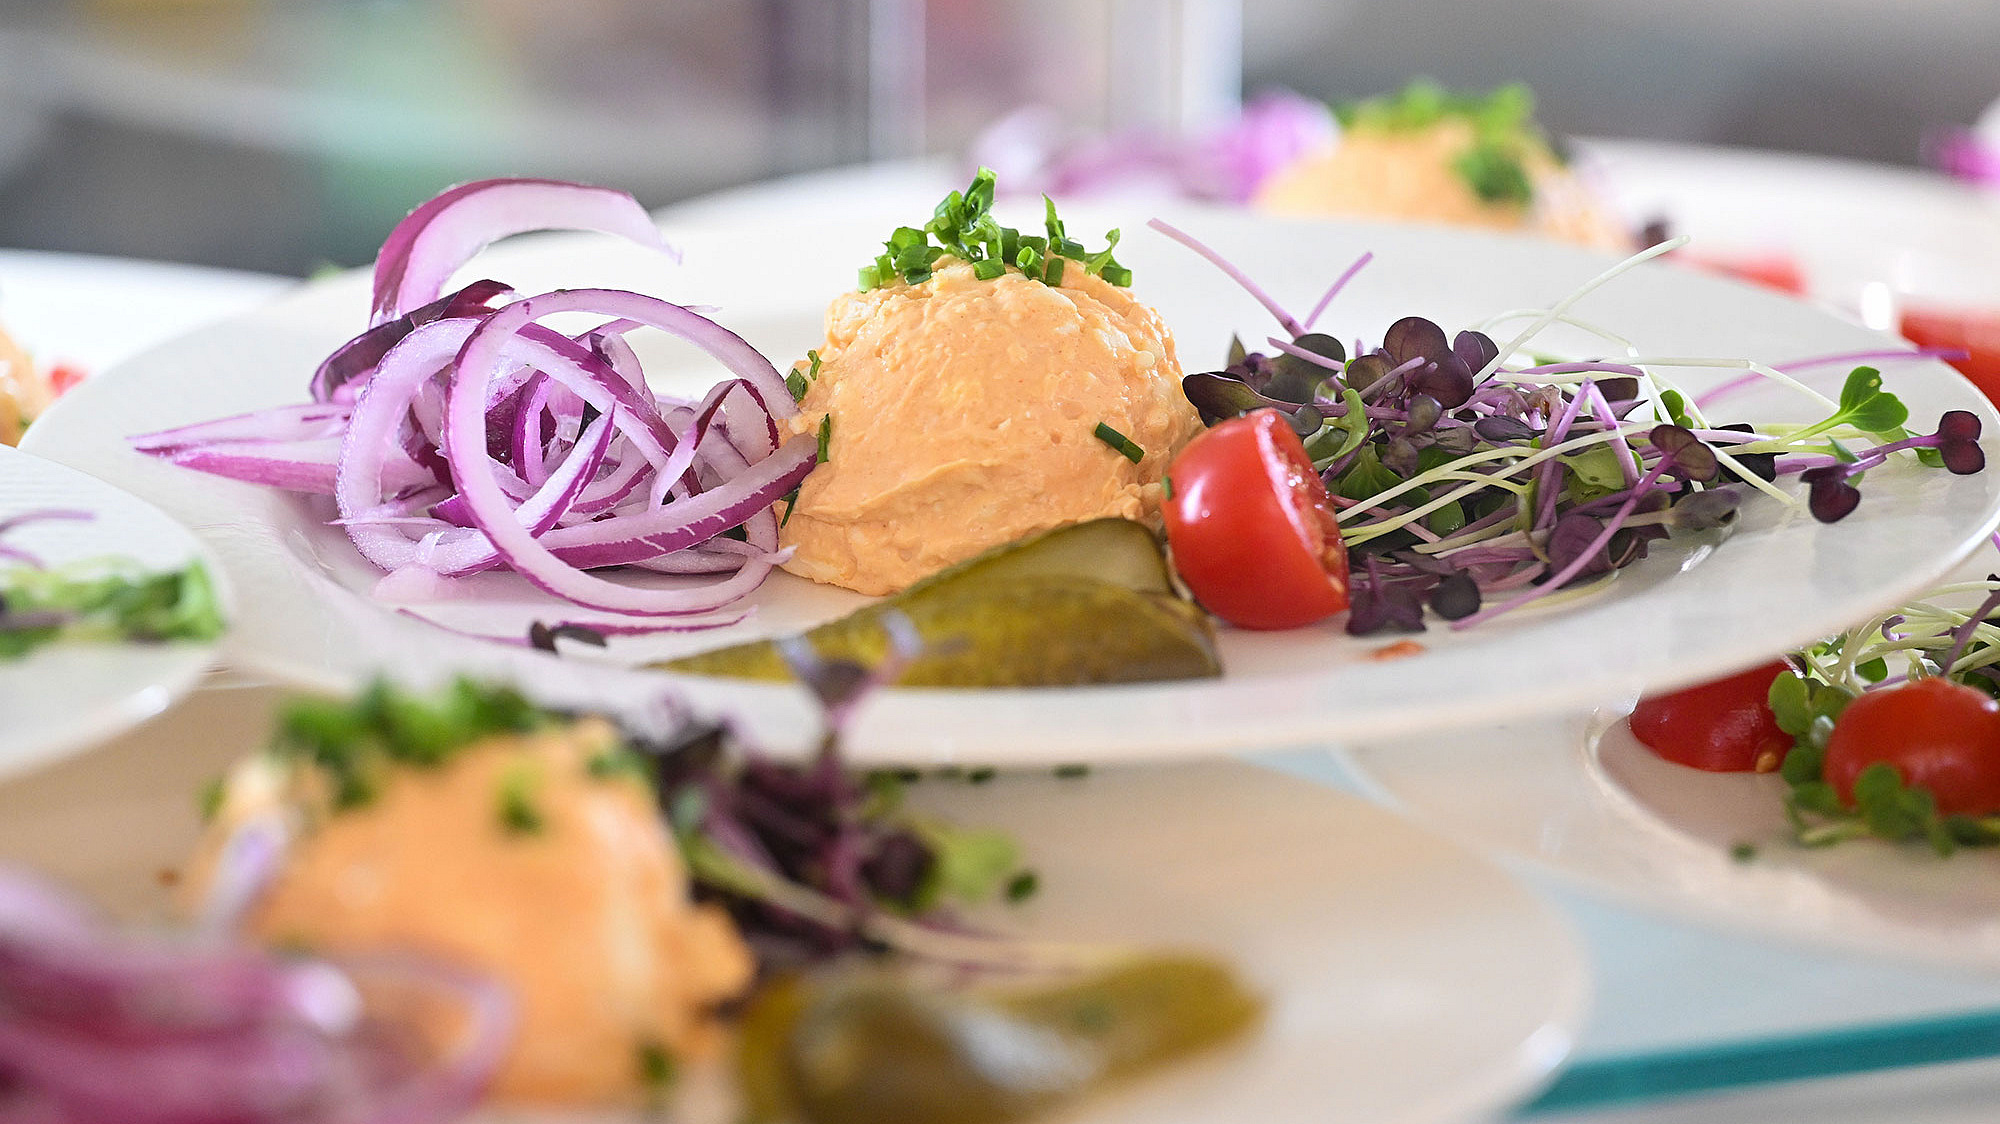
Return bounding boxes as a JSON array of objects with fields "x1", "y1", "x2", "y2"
[{"x1": 0, "y1": 870, "x2": 514, "y2": 1124}]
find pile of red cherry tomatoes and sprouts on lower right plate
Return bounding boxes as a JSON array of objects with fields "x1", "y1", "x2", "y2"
[{"x1": 1630, "y1": 556, "x2": 2000, "y2": 854}]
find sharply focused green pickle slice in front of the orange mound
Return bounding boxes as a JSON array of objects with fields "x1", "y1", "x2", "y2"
[{"x1": 654, "y1": 518, "x2": 1222, "y2": 686}]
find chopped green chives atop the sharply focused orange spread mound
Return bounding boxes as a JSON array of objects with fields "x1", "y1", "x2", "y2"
[{"x1": 856, "y1": 168, "x2": 1132, "y2": 290}]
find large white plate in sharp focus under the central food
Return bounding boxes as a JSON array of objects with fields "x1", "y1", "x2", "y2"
[{"x1": 15, "y1": 206, "x2": 2000, "y2": 762}]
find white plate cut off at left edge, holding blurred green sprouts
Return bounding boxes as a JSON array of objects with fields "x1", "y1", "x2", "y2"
[{"x1": 0, "y1": 446, "x2": 226, "y2": 776}]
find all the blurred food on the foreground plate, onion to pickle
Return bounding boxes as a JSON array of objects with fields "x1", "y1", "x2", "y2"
[{"x1": 0, "y1": 668, "x2": 1262, "y2": 1124}]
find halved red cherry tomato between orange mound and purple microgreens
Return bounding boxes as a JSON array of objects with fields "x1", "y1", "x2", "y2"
[{"x1": 1166, "y1": 410, "x2": 1348, "y2": 628}]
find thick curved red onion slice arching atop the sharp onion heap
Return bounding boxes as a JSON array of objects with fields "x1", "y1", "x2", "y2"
[{"x1": 374, "y1": 180, "x2": 678, "y2": 324}]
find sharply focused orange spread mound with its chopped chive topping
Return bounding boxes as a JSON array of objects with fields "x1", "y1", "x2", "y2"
[{"x1": 780, "y1": 172, "x2": 1202, "y2": 594}]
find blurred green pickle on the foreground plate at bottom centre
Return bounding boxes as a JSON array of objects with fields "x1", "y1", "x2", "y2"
[{"x1": 740, "y1": 956, "x2": 1262, "y2": 1124}]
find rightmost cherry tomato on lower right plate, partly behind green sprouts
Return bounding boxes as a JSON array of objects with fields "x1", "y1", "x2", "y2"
[{"x1": 1824, "y1": 678, "x2": 2000, "y2": 816}]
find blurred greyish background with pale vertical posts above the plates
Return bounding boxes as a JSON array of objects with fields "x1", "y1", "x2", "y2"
[{"x1": 0, "y1": 0, "x2": 2000, "y2": 274}]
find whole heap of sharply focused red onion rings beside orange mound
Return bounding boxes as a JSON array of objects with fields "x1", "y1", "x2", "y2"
[{"x1": 134, "y1": 180, "x2": 816, "y2": 630}]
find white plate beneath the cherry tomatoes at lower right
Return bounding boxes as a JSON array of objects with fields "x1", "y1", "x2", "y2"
[{"x1": 1342, "y1": 688, "x2": 2000, "y2": 970}]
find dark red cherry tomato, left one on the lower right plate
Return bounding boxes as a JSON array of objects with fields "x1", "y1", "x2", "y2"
[{"x1": 1628, "y1": 660, "x2": 1792, "y2": 772}]
